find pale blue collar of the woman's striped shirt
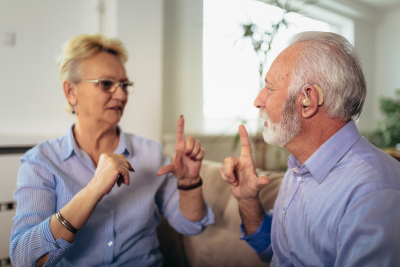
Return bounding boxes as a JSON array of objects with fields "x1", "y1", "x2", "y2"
[{"x1": 61, "y1": 124, "x2": 132, "y2": 160}]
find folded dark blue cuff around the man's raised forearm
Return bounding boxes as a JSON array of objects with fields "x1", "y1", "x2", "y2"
[{"x1": 240, "y1": 212, "x2": 272, "y2": 253}]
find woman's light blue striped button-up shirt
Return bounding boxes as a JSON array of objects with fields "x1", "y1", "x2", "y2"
[{"x1": 10, "y1": 126, "x2": 214, "y2": 266}]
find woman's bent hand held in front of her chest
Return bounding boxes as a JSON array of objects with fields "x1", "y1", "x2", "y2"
[{"x1": 88, "y1": 154, "x2": 134, "y2": 200}]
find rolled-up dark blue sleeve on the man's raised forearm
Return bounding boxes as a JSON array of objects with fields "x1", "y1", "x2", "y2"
[{"x1": 240, "y1": 212, "x2": 273, "y2": 262}]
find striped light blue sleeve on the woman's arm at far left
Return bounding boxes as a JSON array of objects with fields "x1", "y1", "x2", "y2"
[{"x1": 10, "y1": 160, "x2": 74, "y2": 266}]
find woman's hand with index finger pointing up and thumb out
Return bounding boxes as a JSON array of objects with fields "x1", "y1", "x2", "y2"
[{"x1": 157, "y1": 115, "x2": 205, "y2": 185}]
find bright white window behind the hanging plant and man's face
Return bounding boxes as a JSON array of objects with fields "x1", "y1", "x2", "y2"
[{"x1": 203, "y1": 0, "x2": 338, "y2": 134}]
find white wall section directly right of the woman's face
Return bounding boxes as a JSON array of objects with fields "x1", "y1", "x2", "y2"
[{"x1": 117, "y1": 0, "x2": 163, "y2": 141}]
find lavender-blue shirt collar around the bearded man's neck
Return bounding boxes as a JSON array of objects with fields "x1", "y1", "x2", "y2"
[{"x1": 288, "y1": 120, "x2": 361, "y2": 184}]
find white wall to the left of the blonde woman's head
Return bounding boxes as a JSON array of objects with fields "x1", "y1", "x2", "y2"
[{"x1": 0, "y1": 0, "x2": 97, "y2": 138}]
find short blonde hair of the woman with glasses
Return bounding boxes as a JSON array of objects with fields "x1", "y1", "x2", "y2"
[{"x1": 58, "y1": 33, "x2": 128, "y2": 82}]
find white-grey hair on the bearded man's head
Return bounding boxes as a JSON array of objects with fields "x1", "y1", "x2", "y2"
[{"x1": 289, "y1": 31, "x2": 367, "y2": 121}]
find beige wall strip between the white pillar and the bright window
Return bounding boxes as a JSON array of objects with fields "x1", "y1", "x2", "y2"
[{"x1": 163, "y1": 0, "x2": 203, "y2": 133}]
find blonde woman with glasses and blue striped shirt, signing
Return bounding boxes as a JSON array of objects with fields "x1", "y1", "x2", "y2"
[{"x1": 10, "y1": 34, "x2": 213, "y2": 266}]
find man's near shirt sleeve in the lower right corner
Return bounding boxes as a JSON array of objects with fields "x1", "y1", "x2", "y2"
[{"x1": 335, "y1": 188, "x2": 400, "y2": 266}]
